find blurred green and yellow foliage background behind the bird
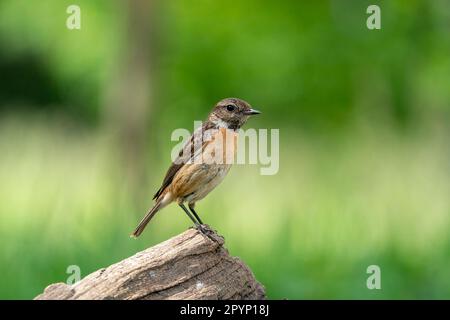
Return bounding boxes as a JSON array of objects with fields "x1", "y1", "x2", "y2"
[{"x1": 0, "y1": 0, "x2": 450, "y2": 299}]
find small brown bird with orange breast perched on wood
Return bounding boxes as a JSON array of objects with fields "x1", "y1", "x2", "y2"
[{"x1": 131, "y1": 98, "x2": 260, "y2": 237}]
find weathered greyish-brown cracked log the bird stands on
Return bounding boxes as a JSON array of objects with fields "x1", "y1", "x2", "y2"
[{"x1": 35, "y1": 229, "x2": 265, "y2": 300}]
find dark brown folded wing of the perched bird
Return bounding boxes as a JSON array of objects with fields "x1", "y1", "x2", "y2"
[{"x1": 153, "y1": 121, "x2": 214, "y2": 200}]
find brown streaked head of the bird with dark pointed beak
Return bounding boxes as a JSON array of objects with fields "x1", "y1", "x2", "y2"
[{"x1": 208, "y1": 98, "x2": 261, "y2": 129}]
